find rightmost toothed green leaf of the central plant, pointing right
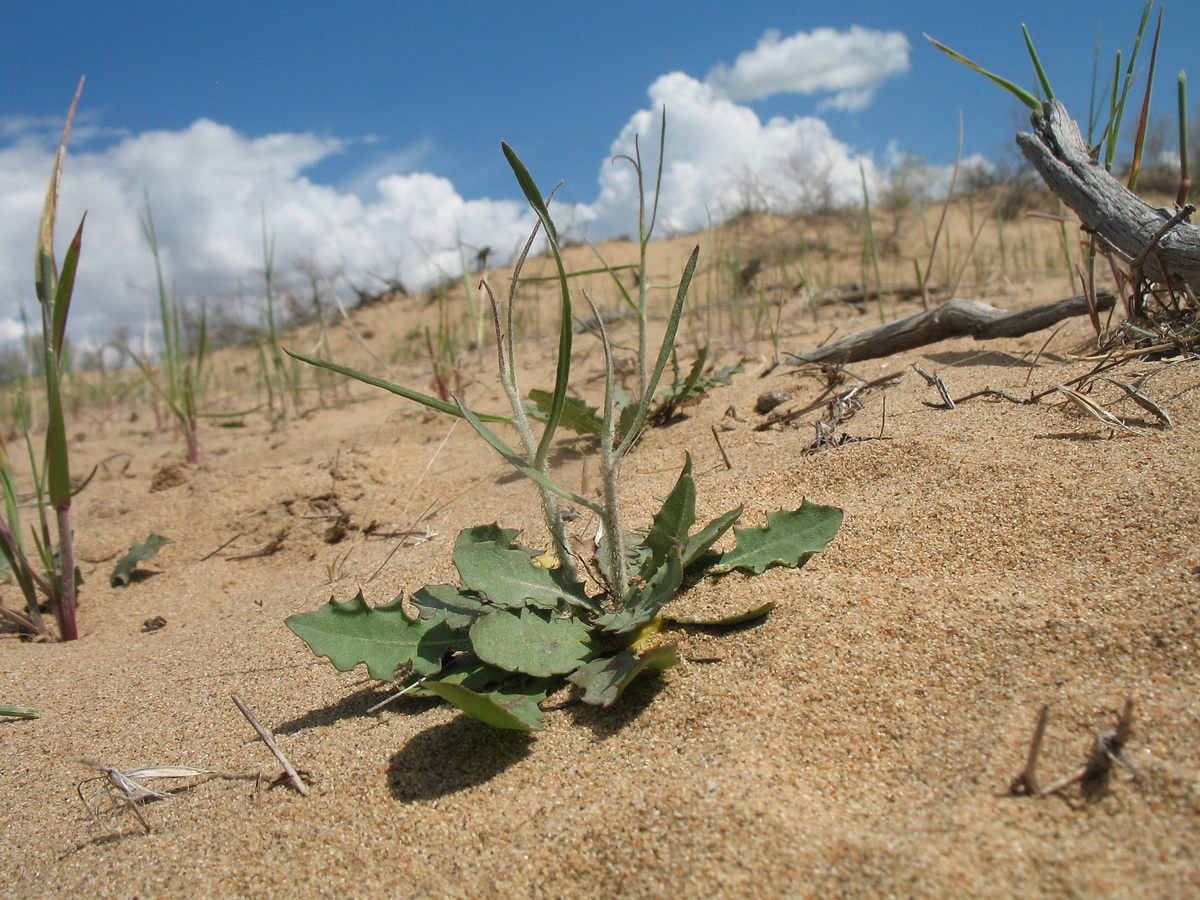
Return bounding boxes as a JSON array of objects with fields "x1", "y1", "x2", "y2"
[{"x1": 708, "y1": 500, "x2": 842, "y2": 575}]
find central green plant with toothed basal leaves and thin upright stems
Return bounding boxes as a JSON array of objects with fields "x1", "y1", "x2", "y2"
[{"x1": 287, "y1": 125, "x2": 842, "y2": 731}]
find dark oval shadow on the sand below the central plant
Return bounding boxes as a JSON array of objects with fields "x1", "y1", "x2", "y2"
[{"x1": 388, "y1": 715, "x2": 535, "y2": 802}]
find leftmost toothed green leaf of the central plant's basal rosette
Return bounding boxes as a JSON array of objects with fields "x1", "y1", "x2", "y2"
[{"x1": 287, "y1": 592, "x2": 469, "y2": 682}]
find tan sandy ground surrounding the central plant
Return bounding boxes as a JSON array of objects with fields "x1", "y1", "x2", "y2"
[{"x1": 0, "y1": 217, "x2": 1200, "y2": 898}]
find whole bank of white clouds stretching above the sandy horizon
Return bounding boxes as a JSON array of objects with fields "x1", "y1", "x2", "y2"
[{"x1": 0, "y1": 26, "x2": 910, "y2": 343}]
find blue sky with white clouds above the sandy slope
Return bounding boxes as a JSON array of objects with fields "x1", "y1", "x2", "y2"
[{"x1": 0, "y1": 0, "x2": 1200, "y2": 341}]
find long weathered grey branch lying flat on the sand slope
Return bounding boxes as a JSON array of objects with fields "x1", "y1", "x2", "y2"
[{"x1": 787, "y1": 290, "x2": 1116, "y2": 365}]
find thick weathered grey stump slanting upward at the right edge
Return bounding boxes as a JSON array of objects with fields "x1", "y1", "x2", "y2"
[{"x1": 1016, "y1": 100, "x2": 1200, "y2": 293}]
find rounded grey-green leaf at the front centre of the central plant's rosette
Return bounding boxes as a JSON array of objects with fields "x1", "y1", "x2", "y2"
[{"x1": 470, "y1": 608, "x2": 600, "y2": 678}]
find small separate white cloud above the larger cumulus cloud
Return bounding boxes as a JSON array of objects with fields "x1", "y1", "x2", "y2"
[{"x1": 707, "y1": 25, "x2": 908, "y2": 110}]
